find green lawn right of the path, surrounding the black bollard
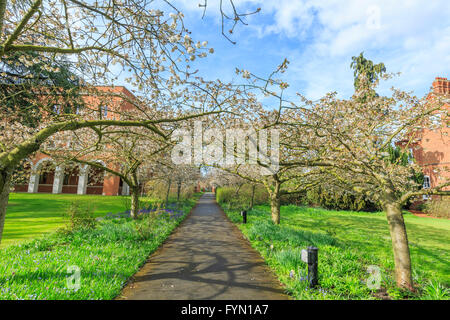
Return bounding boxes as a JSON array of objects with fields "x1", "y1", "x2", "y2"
[{"x1": 226, "y1": 206, "x2": 450, "y2": 299}]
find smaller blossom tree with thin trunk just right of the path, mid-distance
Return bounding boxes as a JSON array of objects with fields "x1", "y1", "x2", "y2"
[{"x1": 209, "y1": 60, "x2": 327, "y2": 224}]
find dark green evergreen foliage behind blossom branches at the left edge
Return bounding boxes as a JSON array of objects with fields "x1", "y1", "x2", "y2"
[{"x1": 0, "y1": 52, "x2": 82, "y2": 128}]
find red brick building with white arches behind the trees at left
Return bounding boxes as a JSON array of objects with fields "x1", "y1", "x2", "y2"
[{"x1": 14, "y1": 86, "x2": 134, "y2": 196}]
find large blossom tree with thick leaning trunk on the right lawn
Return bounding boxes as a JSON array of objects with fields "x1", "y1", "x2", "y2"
[{"x1": 298, "y1": 74, "x2": 450, "y2": 289}]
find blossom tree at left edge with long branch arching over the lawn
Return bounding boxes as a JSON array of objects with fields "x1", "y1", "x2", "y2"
[{"x1": 0, "y1": 0, "x2": 255, "y2": 244}]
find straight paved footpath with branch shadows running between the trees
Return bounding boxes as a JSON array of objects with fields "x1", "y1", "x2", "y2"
[{"x1": 117, "y1": 194, "x2": 288, "y2": 300}]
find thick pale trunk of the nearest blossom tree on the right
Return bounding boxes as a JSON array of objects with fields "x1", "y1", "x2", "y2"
[{"x1": 384, "y1": 202, "x2": 414, "y2": 290}]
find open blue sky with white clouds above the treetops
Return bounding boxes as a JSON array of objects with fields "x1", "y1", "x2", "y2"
[{"x1": 170, "y1": 0, "x2": 450, "y2": 99}]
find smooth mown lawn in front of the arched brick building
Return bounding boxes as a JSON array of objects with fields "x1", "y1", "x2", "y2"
[{"x1": 0, "y1": 193, "x2": 129, "y2": 248}]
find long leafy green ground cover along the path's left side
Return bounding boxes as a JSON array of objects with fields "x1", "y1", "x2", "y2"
[{"x1": 0, "y1": 194, "x2": 199, "y2": 300}]
